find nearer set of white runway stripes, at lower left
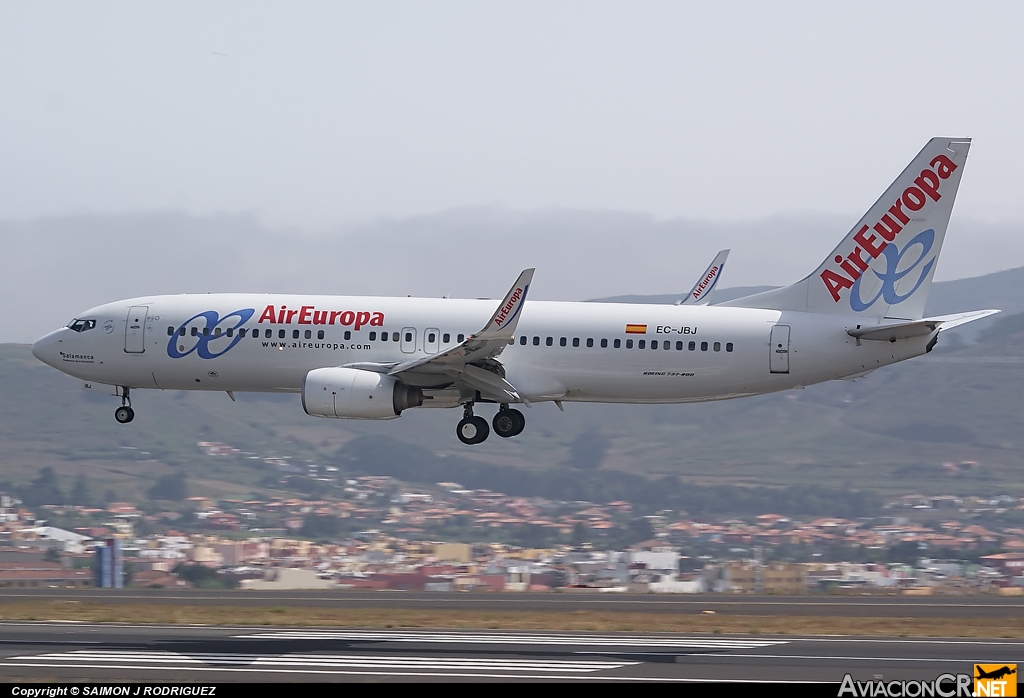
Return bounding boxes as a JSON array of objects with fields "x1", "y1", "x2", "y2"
[{"x1": 2, "y1": 650, "x2": 641, "y2": 675}]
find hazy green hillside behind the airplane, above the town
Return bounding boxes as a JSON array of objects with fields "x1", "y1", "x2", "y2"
[{"x1": 6, "y1": 270, "x2": 1024, "y2": 496}]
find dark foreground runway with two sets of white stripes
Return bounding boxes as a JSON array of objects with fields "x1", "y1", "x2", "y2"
[{"x1": 0, "y1": 622, "x2": 1024, "y2": 685}]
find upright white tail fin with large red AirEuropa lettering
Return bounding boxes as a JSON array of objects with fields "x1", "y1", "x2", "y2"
[{"x1": 721, "y1": 138, "x2": 971, "y2": 320}]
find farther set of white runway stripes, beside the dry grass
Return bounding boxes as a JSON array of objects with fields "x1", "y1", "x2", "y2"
[{"x1": 234, "y1": 630, "x2": 790, "y2": 650}]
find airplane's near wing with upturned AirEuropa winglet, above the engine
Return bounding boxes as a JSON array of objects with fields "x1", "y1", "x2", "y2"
[{"x1": 345, "y1": 269, "x2": 535, "y2": 402}]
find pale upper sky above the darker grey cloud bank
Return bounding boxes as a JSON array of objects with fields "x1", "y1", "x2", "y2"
[{"x1": 0, "y1": 0, "x2": 1024, "y2": 227}]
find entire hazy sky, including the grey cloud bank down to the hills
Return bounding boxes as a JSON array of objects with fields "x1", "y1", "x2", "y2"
[{"x1": 0, "y1": 0, "x2": 1024, "y2": 342}]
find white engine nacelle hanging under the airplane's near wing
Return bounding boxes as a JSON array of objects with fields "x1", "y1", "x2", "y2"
[{"x1": 302, "y1": 367, "x2": 423, "y2": 420}]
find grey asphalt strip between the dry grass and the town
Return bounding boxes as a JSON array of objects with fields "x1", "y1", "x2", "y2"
[{"x1": 0, "y1": 588, "x2": 1024, "y2": 621}]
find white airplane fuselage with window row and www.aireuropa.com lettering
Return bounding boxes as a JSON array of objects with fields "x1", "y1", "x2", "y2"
[{"x1": 33, "y1": 294, "x2": 934, "y2": 406}]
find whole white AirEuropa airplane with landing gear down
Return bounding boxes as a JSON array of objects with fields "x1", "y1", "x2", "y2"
[{"x1": 32, "y1": 138, "x2": 998, "y2": 444}]
